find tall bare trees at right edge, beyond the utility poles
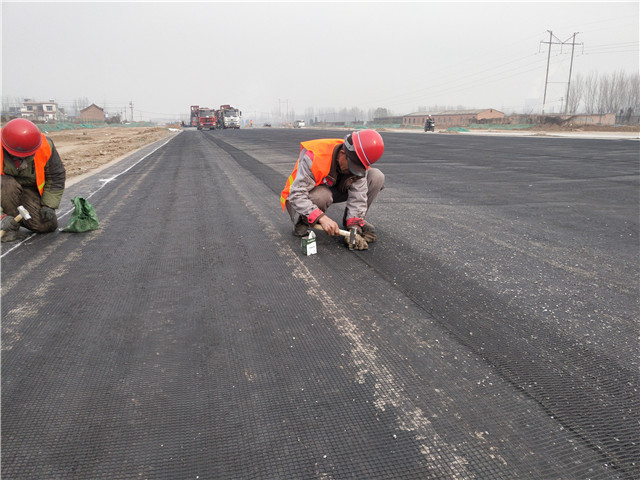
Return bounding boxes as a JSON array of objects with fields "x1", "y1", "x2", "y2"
[{"x1": 566, "y1": 71, "x2": 640, "y2": 115}]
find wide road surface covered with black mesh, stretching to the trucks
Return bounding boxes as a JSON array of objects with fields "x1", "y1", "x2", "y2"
[{"x1": 2, "y1": 129, "x2": 640, "y2": 480}]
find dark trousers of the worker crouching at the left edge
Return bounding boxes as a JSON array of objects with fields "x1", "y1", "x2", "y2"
[{"x1": 0, "y1": 175, "x2": 58, "y2": 233}]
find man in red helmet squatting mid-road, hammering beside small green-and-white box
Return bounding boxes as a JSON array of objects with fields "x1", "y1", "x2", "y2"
[{"x1": 280, "y1": 130, "x2": 384, "y2": 250}]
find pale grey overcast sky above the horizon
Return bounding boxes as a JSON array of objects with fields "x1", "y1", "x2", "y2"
[{"x1": 2, "y1": 0, "x2": 639, "y2": 121}]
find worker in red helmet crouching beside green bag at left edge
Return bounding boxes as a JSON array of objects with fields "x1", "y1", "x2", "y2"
[{"x1": 0, "y1": 118, "x2": 66, "y2": 242}]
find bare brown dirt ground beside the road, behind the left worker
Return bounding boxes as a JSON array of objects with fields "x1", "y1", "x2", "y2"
[{"x1": 46, "y1": 127, "x2": 172, "y2": 179}]
